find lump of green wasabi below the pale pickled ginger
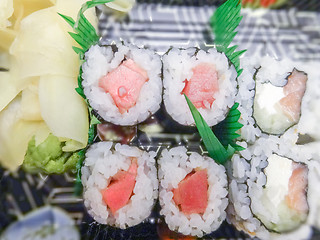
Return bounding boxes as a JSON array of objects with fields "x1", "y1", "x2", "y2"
[{"x1": 23, "y1": 134, "x2": 79, "y2": 174}]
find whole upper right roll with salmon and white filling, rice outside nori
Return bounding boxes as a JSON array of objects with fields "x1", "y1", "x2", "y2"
[{"x1": 236, "y1": 56, "x2": 309, "y2": 144}]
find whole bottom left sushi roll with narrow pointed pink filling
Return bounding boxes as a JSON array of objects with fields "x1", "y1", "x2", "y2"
[{"x1": 81, "y1": 142, "x2": 158, "y2": 229}]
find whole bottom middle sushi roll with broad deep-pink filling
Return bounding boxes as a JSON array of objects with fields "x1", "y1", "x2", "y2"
[{"x1": 158, "y1": 147, "x2": 228, "y2": 237}]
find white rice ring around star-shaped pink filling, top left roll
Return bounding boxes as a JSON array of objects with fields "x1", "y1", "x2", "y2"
[{"x1": 82, "y1": 43, "x2": 162, "y2": 125}]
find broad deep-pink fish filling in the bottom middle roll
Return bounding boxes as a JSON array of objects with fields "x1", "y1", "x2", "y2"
[{"x1": 173, "y1": 170, "x2": 208, "y2": 214}]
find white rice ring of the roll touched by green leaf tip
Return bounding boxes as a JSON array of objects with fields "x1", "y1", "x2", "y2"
[{"x1": 162, "y1": 48, "x2": 237, "y2": 126}]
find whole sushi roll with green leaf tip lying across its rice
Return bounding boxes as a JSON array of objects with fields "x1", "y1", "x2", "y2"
[{"x1": 163, "y1": 48, "x2": 237, "y2": 126}]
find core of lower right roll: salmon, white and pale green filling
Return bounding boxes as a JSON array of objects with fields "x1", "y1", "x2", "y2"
[{"x1": 249, "y1": 153, "x2": 309, "y2": 232}]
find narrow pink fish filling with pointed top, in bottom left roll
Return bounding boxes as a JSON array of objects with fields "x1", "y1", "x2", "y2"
[{"x1": 101, "y1": 158, "x2": 138, "y2": 215}]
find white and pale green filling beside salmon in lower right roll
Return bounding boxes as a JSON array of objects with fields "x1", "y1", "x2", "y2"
[{"x1": 254, "y1": 154, "x2": 308, "y2": 232}]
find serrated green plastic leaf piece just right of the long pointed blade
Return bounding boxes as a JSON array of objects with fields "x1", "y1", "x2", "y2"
[{"x1": 213, "y1": 103, "x2": 245, "y2": 151}]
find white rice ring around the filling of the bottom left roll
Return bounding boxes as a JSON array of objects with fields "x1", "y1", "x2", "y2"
[{"x1": 81, "y1": 142, "x2": 158, "y2": 229}]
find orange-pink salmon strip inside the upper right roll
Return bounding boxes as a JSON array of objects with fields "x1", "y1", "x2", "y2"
[{"x1": 280, "y1": 69, "x2": 308, "y2": 122}]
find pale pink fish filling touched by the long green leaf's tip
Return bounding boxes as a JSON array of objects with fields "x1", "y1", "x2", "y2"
[{"x1": 181, "y1": 63, "x2": 219, "y2": 108}]
